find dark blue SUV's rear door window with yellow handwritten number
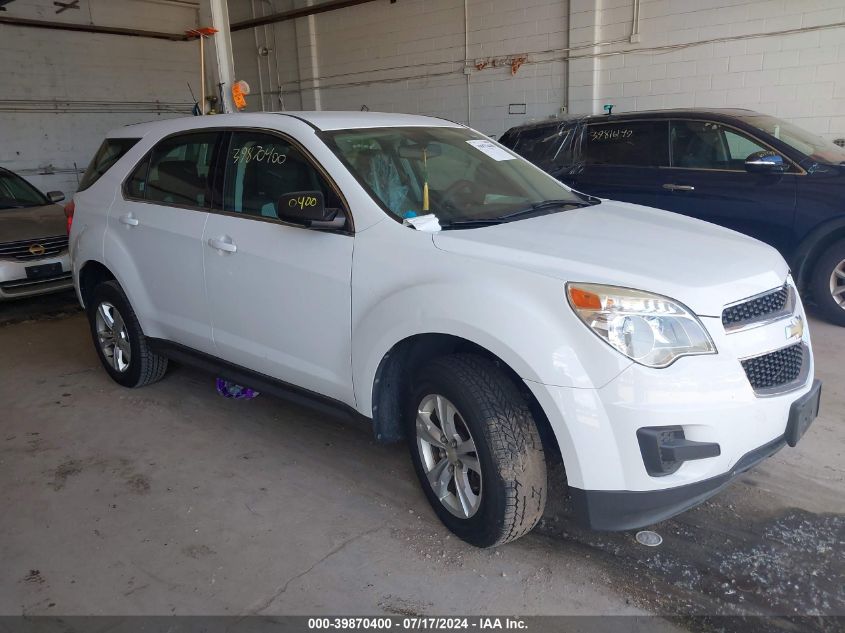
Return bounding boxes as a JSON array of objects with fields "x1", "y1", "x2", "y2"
[{"x1": 581, "y1": 121, "x2": 669, "y2": 167}]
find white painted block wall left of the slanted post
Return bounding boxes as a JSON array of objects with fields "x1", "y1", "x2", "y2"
[{"x1": 0, "y1": 0, "x2": 199, "y2": 196}]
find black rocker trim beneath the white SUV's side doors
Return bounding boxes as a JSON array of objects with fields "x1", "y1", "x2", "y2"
[{"x1": 147, "y1": 338, "x2": 372, "y2": 424}]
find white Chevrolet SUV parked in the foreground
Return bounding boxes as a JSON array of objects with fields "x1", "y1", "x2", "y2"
[{"x1": 71, "y1": 112, "x2": 820, "y2": 546}]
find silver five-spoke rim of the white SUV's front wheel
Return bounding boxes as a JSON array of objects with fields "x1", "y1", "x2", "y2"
[{"x1": 416, "y1": 394, "x2": 482, "y2": 519}]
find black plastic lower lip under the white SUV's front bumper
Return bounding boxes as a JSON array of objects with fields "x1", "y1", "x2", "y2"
[{"x1": 569, "y1": 436, "x2": 786, "y2": 532}]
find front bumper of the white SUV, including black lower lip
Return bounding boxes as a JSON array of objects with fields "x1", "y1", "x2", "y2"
[{"x1": 526, "y1": 294, "x2": 818, "y2": 530}]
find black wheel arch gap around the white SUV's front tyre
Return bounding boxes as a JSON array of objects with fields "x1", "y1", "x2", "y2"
[{"x1": 371, "y1": 332, "x2": 560, "y2": 460}]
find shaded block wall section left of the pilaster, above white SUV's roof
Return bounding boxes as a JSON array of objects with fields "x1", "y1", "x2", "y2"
[{"x1": 229, "y1": 0, "x2": 568, "y2": 136}]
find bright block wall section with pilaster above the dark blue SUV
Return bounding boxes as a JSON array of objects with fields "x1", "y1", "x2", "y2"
[{"x1": 570, "y1": 0, "x2": 845, "y2": 139}]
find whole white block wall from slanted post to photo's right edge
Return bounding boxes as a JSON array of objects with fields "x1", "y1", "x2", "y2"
[{"x1": 229, "y1": 0, "x2": 845, "y2": 143}]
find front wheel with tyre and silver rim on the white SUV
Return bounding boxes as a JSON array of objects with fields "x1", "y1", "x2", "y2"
[{"x1": 407, "y1": 354, "x2": 547, "y2": 547}]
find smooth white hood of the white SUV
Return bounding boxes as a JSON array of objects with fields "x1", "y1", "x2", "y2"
[{"x1": 434, "y1": 200, "x2": 789, "y2": 316}]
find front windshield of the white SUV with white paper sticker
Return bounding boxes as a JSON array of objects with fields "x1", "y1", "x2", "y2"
[{"x1": 322, "y1": 127, "x2": 587, "y2": 227}]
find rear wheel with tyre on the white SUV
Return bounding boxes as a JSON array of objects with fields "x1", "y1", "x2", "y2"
[{"x1": 87, "y1": 281, "x2": 167, "y2": 388}]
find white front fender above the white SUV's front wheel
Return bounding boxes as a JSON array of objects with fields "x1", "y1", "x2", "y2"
[{"x1": 352, "y1": 251, "x2": 631, "y2": 416}]
